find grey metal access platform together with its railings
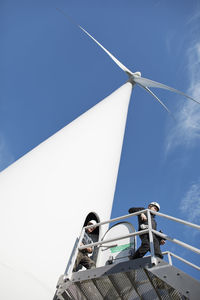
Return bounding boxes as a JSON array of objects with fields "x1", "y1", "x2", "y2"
[{"x1": 54, "y1": 210, "x2": 200, "y2": 300}]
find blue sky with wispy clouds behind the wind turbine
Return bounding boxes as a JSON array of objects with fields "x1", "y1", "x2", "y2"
[{"x1": 0, "y1": 0, "x2": 200, "y2": 279}]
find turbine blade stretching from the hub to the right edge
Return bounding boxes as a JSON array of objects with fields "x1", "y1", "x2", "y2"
[{"x1": 133, "y1": 76, "x2": 200, "y2": 104}]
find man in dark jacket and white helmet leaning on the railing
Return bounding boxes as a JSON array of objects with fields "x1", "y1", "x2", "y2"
[{"x1": 128, "y1": 202, "x2": 165, "y2": 259}]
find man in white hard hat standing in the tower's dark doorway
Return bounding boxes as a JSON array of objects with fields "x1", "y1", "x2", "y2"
[{"x1": 73, "y1": 220, "x2": 97, "y2": 272}]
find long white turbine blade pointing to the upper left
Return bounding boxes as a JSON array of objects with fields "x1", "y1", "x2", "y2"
[{"x1": 57, "y1": 8, "x2": 133, "y2": 76}]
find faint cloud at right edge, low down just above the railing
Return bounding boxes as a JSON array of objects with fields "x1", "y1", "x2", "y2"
[{"x1": 180, "y1": 178, "x2": 200, "y2": 224}]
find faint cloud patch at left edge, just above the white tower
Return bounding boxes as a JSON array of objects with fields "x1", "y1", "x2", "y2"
[{"x1": 0, "y1": 133, "x2": 15, "y2": 171}]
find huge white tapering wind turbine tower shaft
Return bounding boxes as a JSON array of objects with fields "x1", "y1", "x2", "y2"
[{"x1": 0, "y1": 83, "x2": 132, "y2": 300}]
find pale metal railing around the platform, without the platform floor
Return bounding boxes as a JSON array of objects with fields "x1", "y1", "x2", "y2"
[{"x1": 66, "y1": 209, "x2": 200, "y2": 278}]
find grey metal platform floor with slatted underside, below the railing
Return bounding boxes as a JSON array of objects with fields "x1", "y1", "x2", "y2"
[{"x1": 54, "y1": 257, "x2": 200, "y2": 300}]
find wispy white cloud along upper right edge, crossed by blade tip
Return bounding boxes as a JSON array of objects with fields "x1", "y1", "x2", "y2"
[{"x1": 166, "y1": 5, "x2": 200, "y2": 152}]
